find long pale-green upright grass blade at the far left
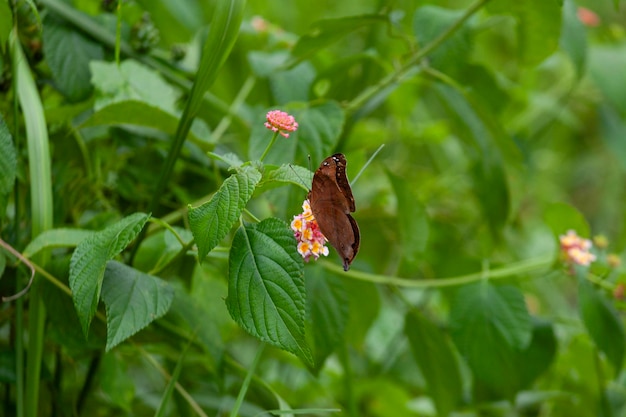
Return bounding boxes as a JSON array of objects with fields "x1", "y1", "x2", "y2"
[{"x1": 9, "y1": 29, "x2": 53, "y2": 417}]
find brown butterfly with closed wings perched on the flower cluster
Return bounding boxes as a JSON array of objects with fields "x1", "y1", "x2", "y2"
[{"x1": 308, "y1": 153, "x2": 361, "y2": 271}]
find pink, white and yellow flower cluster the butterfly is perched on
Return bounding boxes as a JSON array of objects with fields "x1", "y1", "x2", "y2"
[{"x1": 291, "y1": 200, "x2": 328, "y2": 262}]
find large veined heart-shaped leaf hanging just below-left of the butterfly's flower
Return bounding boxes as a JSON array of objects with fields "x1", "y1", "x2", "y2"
[{"x1": 226, "y1": 218, "x2": 313, "y2": 366}]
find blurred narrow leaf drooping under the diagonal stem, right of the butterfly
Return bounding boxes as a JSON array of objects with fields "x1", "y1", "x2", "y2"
[{"x1": 435, "y1": 84, "x2": 510, "y2": 233}]
